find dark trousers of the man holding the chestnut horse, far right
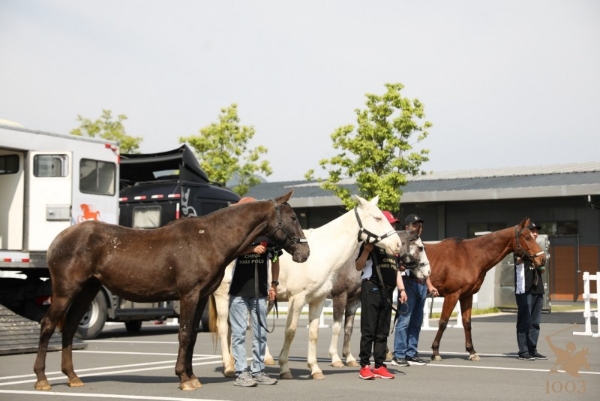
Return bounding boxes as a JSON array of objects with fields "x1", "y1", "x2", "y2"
[{"x1": 515, "y1": 293, "x2": 544, "y2": 355}]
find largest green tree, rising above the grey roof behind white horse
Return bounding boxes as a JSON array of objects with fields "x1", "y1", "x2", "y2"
[{"x1": 305, "y1": 83, "x2": 431, "y2": 212}]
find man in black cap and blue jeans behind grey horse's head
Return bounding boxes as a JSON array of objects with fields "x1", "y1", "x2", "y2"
[{"x1": 392, "y1": 214, "x2": 439, "y2": 366}]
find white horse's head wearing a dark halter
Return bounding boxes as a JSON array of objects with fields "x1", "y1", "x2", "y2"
[{"x1": 354, "y1": 196, "x2": 402, "y2": 255}]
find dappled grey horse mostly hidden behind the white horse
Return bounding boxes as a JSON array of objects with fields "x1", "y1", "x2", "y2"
[{"x1": 329, "y1": 238, "x2": 431, "y2": 367}]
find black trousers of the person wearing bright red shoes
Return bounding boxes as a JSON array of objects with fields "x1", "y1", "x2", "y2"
[{"x1": 359, "y1": 281, "x2": 392, "y2": 368}]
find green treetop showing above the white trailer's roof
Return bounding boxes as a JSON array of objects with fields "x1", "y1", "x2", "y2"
[{"x1": 71, "y1": 110, "x2": 142, "y2": 153}]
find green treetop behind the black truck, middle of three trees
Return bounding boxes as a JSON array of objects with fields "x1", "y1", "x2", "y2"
[{"x1": 179, "y1": 104, "x2": 273, "y2": 196}]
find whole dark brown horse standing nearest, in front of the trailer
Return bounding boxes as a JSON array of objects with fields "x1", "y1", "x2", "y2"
[{"x1": 33, "y1": 191, "x2": 310, "y2": 390}]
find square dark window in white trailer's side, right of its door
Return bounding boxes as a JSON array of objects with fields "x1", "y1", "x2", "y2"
[{"x1": 79, "y1": 159, "x2": 117, "y2": 196}]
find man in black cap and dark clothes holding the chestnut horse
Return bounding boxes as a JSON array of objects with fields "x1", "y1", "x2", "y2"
[{"x1": 514, "y1": 221, "x2": 548, "y2": 361}]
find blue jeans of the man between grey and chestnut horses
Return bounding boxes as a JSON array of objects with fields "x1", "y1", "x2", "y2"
[{"x1": 394, "y1": 279, "x2": 427, "y2": 359}]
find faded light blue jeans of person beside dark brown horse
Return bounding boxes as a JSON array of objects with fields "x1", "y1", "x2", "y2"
[{"x1": 229, "y1": 295, "x2": 267, "y2": 374}]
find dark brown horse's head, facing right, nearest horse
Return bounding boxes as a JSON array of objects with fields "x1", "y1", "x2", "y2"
[{"x1": 265, "y1": 191, "x2": 310, "y2": 263}]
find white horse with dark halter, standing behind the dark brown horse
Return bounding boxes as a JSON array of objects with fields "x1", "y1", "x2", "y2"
[{"x1": 206, "y1": 196, "x2": 409, "y2": 379}]
